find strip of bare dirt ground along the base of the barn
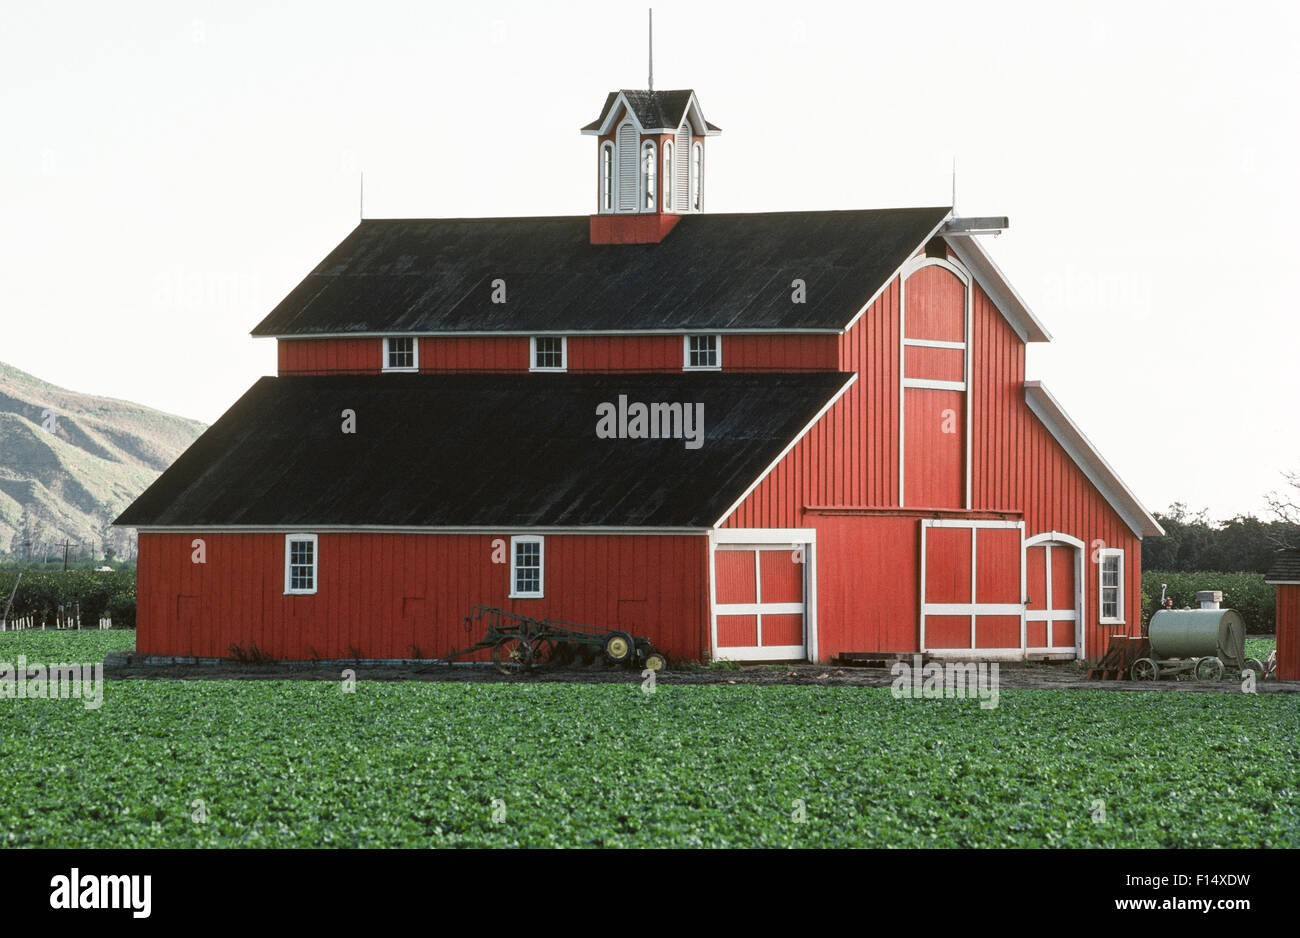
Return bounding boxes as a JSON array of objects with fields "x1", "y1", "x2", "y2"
[{"x1": 104, "y1": 656, "x2": 1300, "y2": 694}]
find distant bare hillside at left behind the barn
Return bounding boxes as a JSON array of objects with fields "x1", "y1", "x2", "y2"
[{"x1": 0, "y1": 362, "x2": 207, "y2": 557}]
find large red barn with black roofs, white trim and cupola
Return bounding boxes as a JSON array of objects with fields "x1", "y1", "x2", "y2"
[{"x1": 118, "y1": 83, "x2": 1161, "y2": 661}]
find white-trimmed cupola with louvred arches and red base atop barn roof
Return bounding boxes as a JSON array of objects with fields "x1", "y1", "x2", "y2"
[{"x1": 582, "y1": 90, "x2": 722, "y2": 244}]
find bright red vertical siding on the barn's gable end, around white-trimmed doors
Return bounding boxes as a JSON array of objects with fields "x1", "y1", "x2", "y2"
[{"x1": 724, "y1": 268, "x2": 1141, "y2": 660}]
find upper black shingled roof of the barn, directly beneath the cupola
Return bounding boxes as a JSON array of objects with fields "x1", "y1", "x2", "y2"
[{"x1": 252, "y1": 208, "x2": 949, "y2": 335}]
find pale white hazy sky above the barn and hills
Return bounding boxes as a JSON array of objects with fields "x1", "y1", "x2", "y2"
[{"x1": 0, "y1": 0, "x2": 1300, "y2": 516}]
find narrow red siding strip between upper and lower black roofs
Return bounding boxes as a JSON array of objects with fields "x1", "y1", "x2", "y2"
[{"x1": 277, "y1": 335, "x2": 840, "y2": 374}]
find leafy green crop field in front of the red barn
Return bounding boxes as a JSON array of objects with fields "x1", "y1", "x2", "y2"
[{"x1": 0, "y1": 633, "x2": 1300, "y2": 847}]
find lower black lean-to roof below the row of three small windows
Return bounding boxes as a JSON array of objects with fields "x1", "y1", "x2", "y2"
[{"x1": 116, "y1": 372, "x2": 852, "y2": 529}]
